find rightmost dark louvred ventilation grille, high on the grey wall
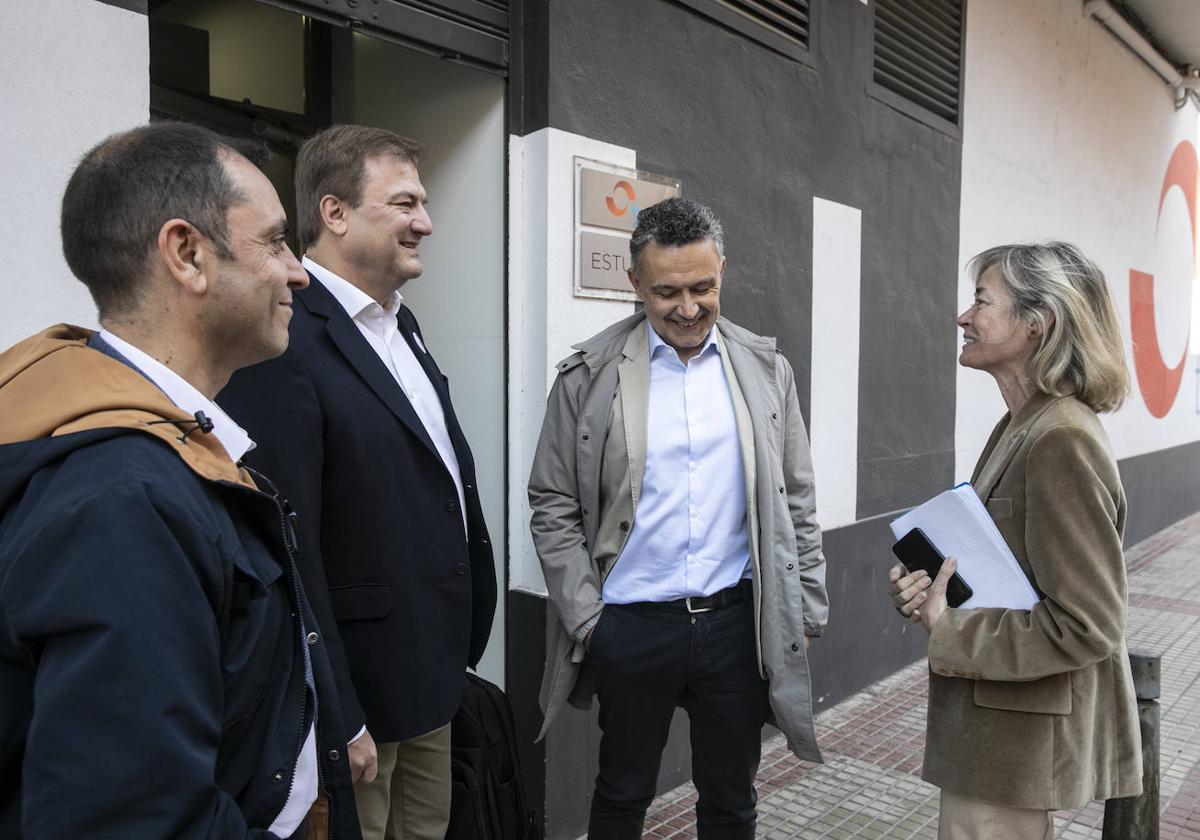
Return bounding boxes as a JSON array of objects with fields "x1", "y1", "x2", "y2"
[{"x1": 874, "y1": 0, "x2": 964, "y2": 125}]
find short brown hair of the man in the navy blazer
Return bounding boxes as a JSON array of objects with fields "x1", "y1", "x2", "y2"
[{"x1": 295, "y1": 125, "x2": 421, "y2": 251}]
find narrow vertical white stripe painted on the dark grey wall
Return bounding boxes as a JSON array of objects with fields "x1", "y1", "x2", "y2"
[{"x1": 809, "y1": 198, "x2": 863, "y2": 529}]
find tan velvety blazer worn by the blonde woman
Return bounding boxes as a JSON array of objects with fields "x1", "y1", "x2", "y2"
[{"x1": 923, "y1": 394, "x2": 1141, "y2": 810}]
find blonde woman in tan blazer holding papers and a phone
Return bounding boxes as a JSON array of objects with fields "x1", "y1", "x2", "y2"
[{"x1": 889, "y1": 242, "x2": 1141, "y2": 840}]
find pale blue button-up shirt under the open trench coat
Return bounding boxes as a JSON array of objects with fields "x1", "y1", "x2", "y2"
[{"x1": 602, "y1": 322, "x2": 750, "y2": 604}]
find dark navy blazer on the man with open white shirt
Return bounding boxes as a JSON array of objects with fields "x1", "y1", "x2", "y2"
[{"x1": 217, "y1": 277, "x2": 496, "y2": 742}]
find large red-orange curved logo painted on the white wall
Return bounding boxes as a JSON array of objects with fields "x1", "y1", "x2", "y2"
[{"x1": 1129, "y1": 140, "x2": 1200, "y2": 418}]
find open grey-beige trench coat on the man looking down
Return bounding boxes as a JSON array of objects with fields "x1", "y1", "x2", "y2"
[{"x1": 529, "y1": 313, "x2": 829, "y2": 761}]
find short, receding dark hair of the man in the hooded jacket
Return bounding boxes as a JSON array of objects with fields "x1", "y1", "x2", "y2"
[{"x1": 60, "y1": 121, "x2": 266, "y2": 318}]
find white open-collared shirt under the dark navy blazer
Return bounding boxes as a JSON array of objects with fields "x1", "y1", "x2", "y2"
[{"x1": 301, "y1": 254, "x2": 467, "y2": 534}]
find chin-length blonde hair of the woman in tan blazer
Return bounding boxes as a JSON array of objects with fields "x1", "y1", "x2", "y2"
[{"x1": 967, "y1": 242, "x2": 1129, "y2": 412}]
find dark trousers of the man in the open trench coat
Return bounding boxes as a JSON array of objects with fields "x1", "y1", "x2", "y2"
[{"x1": 588, "y1": 590, "x2": 768, "y2": 840}]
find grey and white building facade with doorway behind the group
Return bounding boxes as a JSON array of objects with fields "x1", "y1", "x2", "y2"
[{"x1": 0, "y1": 0, "x2": 1200, "y2": 838}]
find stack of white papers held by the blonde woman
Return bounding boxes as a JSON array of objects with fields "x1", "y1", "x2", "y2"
[{"x1": 892, "y1": 482, "x2": 1039, "y2": 610}]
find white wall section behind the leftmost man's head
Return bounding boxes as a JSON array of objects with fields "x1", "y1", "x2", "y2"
[{"x1": 0, "y1": 0, "x2": 150, "y2": 348}]
